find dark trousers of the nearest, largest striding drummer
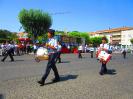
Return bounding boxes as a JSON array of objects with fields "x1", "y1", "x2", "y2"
[{"x1": 42, "y1": 53, "x2": 59, "y2": 82}]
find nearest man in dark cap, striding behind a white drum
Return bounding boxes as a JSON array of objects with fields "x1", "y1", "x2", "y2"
[{"x1": 38, "y1": 29, "x2": 60, "y2": 86}]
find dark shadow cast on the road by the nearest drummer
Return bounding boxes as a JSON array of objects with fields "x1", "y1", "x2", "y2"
[{"x1": 45, "y1": 75, "x2": 78, "y2": 85}]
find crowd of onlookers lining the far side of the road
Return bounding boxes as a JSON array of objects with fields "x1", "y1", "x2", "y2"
[{"x1": 0, "y1": 42, "x2": 133, "y2": 56}]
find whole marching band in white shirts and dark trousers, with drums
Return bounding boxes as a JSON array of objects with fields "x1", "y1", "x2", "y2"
[{"x1": 1, "y1": 29, "x2": 115, "y2": 86}]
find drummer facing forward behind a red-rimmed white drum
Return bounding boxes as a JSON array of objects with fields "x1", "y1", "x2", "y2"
[{"x1": 99, "y1": 37, "x2": 109, "y2": 75}]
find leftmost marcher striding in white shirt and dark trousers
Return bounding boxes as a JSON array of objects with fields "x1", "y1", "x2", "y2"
[{"x1": 1, "y1": 42, "x2": 14, "y2": 62}]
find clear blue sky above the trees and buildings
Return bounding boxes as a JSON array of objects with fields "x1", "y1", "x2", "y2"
[{"x1": 0, "y1": 0, "x2": 133, "y2": 32}]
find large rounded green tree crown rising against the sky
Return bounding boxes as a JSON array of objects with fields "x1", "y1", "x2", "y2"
[{"x1": 18, "y1": 9, "x2": 52, "y2": 40}]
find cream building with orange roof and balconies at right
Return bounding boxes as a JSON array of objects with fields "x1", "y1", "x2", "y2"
[{"x1": 90, "y1": 27, "x2": 133, "y2": 48}]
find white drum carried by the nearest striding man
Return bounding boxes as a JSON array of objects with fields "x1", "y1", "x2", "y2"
[{"x1": 35, "y1": 47, "x2": 49, "y2": 62}]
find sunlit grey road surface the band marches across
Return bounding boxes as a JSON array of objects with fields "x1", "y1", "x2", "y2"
[{"x1": 0, "y1": 53, "x2": 133, "y2": 99}]
